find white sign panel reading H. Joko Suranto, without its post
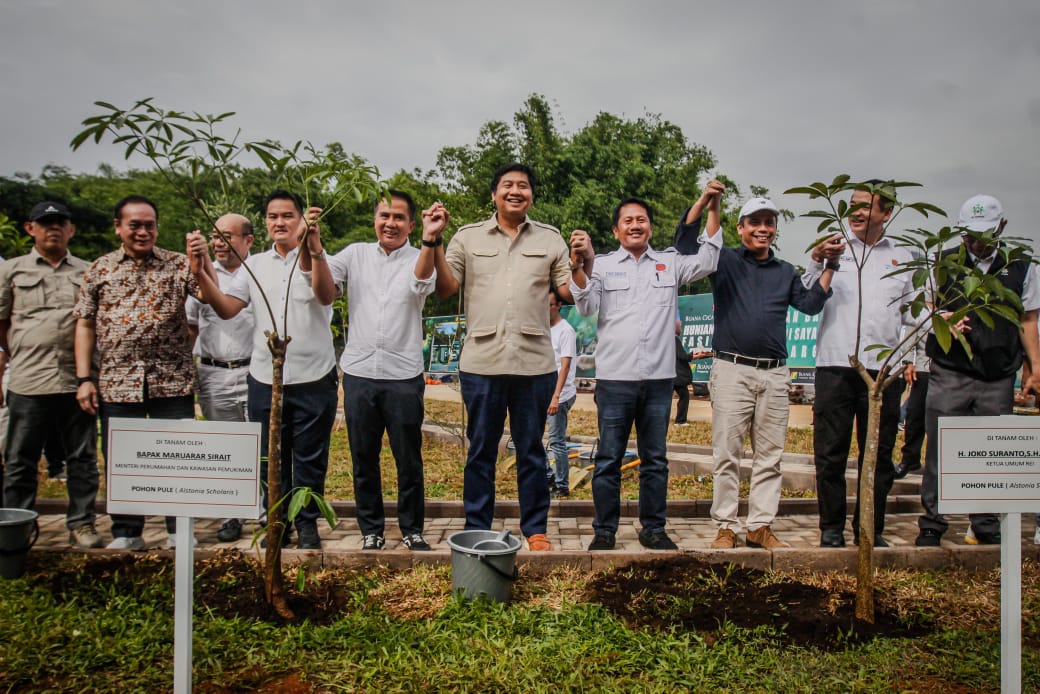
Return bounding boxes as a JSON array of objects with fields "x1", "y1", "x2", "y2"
[{"x1": 937, "y1": 415, "x2": 1040, "y2": 513}]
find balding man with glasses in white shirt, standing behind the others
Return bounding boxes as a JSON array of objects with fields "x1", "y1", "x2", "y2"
[{"x1": 184, "y1": 214, "x2": 254, "y2": 542}]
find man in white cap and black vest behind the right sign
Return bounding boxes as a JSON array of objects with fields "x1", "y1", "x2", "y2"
[{"x1": 916, "y1": 196, "x2": 1040, "y2": 546}]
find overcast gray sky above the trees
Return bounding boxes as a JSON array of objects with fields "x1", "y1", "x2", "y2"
[{"x1": 0, "y1": 0, "x2": 1040, "y2": 260}]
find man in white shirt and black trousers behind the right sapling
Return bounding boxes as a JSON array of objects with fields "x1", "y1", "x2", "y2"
[{"x1": 803, "y1": 180, "x2": 913, "y2": 547}]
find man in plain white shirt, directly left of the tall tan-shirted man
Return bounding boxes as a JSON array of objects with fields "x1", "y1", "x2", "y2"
[{"x1": 329, "y1": 190, "x2": 448, "y2": 551}]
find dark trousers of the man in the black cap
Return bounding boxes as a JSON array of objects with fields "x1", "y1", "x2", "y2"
[{"x1": 3, "y1": 391, "x2": 99, "y2": 530}]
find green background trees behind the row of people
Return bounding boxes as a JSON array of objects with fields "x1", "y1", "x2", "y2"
[{"x1": 0, "y1": 95, "x2": 766, "y2": 323}]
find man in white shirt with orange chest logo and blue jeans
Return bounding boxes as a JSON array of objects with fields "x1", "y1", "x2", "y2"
[{"x1": 570, "y1": 198, "x2": 722, "y2": 549}]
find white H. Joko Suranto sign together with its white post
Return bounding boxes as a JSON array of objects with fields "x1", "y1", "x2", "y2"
[{"x1": 937, "y1": 415, "x2": 1040, "y2": 694}]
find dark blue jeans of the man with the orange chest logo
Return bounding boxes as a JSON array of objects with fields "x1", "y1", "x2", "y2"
[{"x1": 592, "y1": 379, "x2": 672, "y2": 533}]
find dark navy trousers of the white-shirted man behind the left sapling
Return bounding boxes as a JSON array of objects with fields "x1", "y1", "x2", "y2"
[{"x1": 248, "y1": 368, "x2": 338, "y2": 528}]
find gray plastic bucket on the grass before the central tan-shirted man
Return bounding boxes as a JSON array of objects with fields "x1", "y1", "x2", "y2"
[{"x1": 448, "y1": 531, "x2": 520, "y2": 602}]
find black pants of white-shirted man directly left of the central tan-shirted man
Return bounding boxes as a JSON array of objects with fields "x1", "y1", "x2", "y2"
[{"x1": 343, "y1": 374, "x2": 426, "y2": 535}]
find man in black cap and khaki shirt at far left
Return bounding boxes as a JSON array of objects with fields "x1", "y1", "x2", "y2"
[{"x1": 0, "y1": 202, "x2": 102, "y2": 548}]
